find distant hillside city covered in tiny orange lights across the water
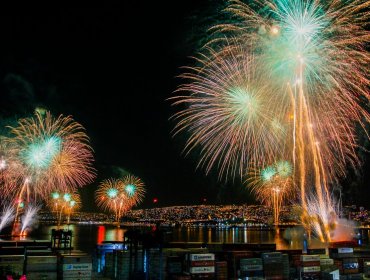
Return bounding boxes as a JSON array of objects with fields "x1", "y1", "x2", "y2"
[{"x1": 40, "y1": 204, "x2": 370, "y2": 226}]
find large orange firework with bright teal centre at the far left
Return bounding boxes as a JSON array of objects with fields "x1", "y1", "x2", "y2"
[{"x1": 6, "y1": 112, "x2": 95, "y2": 201}]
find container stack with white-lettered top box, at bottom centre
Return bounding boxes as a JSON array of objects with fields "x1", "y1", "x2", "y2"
[{"x1": 187, "y1": 253, "x2": 215, "y2": 279}]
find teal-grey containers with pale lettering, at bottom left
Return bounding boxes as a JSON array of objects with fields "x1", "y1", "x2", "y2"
[{"x1": 58, "y1": 253, "x2": 92, "y2": 280}]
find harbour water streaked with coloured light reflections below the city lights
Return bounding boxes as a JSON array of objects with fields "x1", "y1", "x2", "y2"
[{"x1": 23, "y1": 225, "x2": 369, "y2": 252}]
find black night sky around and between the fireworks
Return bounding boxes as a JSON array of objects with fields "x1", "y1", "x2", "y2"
[{"x1": 0, "y1": 4, "x2": 370, "y2": 211}]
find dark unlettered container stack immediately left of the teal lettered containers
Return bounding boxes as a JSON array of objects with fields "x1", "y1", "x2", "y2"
[{"x1": 26, "y1": 255, "x2": 57, "y2": 280}]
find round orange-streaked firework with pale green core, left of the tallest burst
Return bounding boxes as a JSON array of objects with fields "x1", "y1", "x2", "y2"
[{"x1": 172, "y1": 47, "x2": 290, "y2": 177}]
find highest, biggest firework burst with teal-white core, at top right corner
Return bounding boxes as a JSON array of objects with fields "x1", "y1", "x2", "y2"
[{"x1": 209, "y1": 0, "x2": 370, "y2": 179}]
